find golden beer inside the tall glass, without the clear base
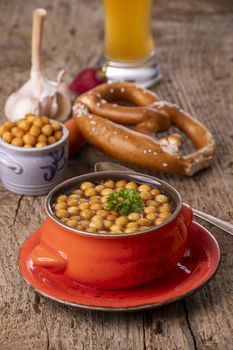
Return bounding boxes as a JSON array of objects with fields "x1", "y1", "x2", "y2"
[{"x1": 103, "y1": 0, "x2": 154, "y2": 63}]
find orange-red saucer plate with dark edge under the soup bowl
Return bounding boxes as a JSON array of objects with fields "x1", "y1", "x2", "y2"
[{"x1": 19, "y1": 222, "x2": 220, "y2": 311}]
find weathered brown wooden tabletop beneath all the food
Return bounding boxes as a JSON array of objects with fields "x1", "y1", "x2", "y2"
[{"x1": 0, "y1": 0, "x2": 233, "y2": 350}]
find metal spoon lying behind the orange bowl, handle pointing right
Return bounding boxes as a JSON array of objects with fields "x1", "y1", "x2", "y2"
[{"x1": 94, "y1": 162, "x2": 233, "y2": 235}]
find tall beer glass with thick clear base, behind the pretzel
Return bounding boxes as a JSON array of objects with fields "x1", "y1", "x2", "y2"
[{"x1": 103, "y1": 0, "x2": 161, "y2": 87}]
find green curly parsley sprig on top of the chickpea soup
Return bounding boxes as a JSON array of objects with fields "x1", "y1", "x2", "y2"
[{"x1": 107, "y1": 188, "x2": 144, "y2": 215}]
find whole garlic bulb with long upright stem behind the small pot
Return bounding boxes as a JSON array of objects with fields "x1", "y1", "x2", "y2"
[{"x1": 5, "y1": 9, "x2": 71, "y2": 122}]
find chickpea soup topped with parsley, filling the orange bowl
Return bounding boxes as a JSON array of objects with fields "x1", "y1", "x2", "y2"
[{"x1": 53, "y1": 179, "x2": 173, "y2": 234}]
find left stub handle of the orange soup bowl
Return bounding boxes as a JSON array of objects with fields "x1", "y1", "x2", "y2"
[{"x1": 31, "y1": 243, "x2": 67, "y2": 272}]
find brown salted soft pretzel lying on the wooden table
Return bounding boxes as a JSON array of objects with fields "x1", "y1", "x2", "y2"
[{"x1": 73, "y1": 82, "x2": 215, "y2": 175}]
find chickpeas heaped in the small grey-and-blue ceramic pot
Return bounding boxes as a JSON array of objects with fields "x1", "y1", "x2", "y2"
[{"x1": 0, "y1": 114, "x2": 63, "y2": 148}]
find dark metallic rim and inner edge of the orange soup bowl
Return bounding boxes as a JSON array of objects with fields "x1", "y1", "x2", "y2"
[{"x1": 45, "y1": 171, "x2": 182, "y2": 238}]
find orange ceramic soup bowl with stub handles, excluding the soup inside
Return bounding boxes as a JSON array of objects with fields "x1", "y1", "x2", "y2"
[{"x1": 32, "y1": 171, "x2": 192, "y2": 289}]
